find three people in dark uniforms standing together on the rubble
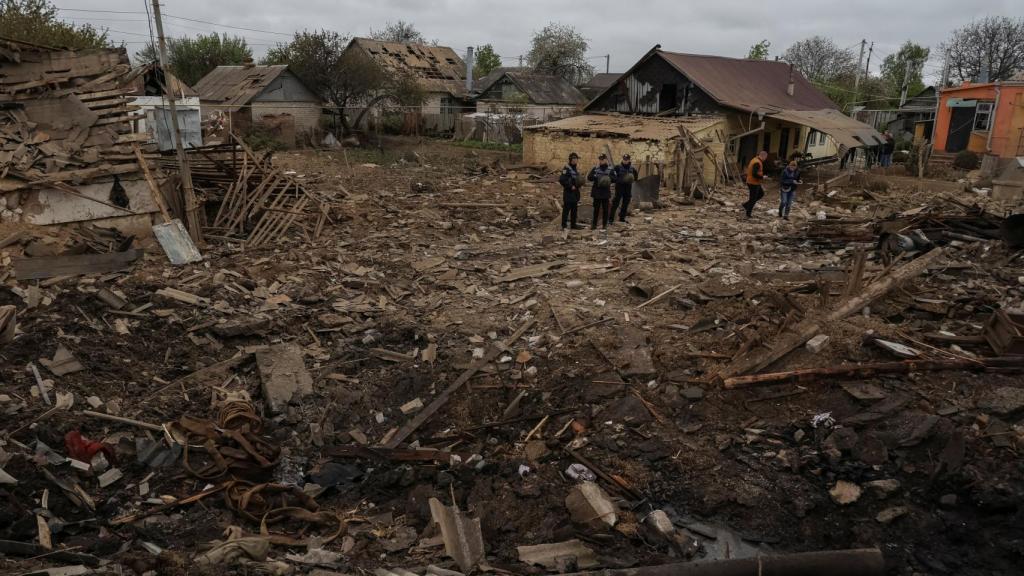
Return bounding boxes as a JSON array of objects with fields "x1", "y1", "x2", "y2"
[{"x1": 558, "y1": 152, "x2": 639, "y2": 230}]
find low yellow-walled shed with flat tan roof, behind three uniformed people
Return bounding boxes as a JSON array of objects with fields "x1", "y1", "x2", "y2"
[{"x1": 522, "y1": 114, "x2": 726, "y2": 184}]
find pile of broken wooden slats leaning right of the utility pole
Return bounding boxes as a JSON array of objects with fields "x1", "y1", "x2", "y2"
[{"x1": 172, "y1": 135, "x2": 327, "y2": 247}]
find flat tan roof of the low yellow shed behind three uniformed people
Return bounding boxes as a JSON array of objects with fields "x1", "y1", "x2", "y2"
[{"x1": 524, "y1": 114, "x2": 725, "y2": 140}]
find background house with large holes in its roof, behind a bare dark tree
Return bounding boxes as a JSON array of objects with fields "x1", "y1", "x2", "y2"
[{"x1": 345, "y1": 38, "x2": 471, "y2": 133}]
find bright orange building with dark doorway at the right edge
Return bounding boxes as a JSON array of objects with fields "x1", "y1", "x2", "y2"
[{"x1": 935, "y1": 81, "x2": 1024, "y2": 158}]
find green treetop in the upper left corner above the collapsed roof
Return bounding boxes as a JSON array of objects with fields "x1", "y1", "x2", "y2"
[{"x1": 0, "y1": 0, "x2": 111, "y2": 49}]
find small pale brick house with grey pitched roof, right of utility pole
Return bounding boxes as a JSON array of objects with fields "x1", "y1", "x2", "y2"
[{"x1": 195, "y1": 64, "x2": 324, "y2": 140}]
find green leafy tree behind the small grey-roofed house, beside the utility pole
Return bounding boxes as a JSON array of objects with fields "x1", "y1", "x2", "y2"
[{"x1": 135, "y1": 33, "x2": 253, "y2": 86}]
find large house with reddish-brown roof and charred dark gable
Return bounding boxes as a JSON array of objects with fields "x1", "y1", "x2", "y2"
[{"x1": 585, "y1": 46, "x2": 882, "y2": 170}]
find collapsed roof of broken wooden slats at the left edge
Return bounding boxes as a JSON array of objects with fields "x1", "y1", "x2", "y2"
[{"x1": 0, "y1": 40, "x2": 148, "y2": 191}]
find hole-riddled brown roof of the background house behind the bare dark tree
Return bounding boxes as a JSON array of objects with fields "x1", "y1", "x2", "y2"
[{"x1": 348, "y1": 38, "x2": 466, "y2": 96}]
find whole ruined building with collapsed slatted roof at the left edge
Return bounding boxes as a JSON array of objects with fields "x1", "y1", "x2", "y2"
[{"x1": 0, "y1": 39, "x2": 169, "y2": 235}]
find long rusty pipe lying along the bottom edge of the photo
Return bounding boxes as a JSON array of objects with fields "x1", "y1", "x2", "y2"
[{"x1": 563, "y1": 548, "x2": 886, "y2": 576}]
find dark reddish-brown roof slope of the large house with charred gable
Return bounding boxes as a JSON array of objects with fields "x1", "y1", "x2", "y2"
[{"x1": 657, "y1": 50, "x2": 836, "y2": 112}]
